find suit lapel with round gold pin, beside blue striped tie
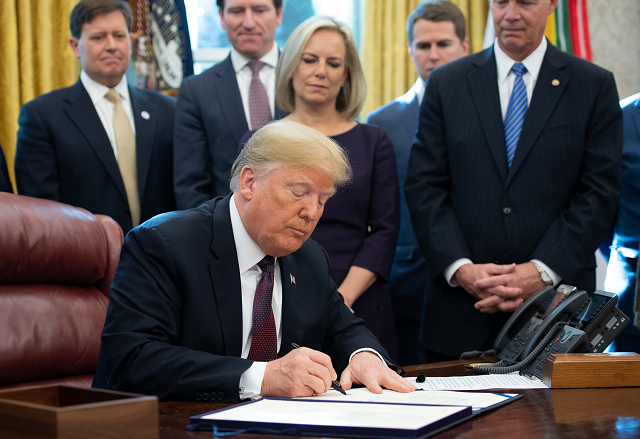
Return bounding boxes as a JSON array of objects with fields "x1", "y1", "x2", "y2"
[{"x1": 506, "y1": 43, "x2": 569, "y2": 185}]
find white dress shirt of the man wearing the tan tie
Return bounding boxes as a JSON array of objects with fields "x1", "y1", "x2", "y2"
[{"x1": 80, "y1": 70, "x2": 136, "y2": 160}]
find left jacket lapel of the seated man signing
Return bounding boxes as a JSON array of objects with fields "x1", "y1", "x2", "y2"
[{"x1": 209, "y1": 195, "x2": 242, "y2": 357}]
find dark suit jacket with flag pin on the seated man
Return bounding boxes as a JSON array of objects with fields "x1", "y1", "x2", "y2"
[{"x1": 94, "y1": 195, "x2": 400, "y2": 402}]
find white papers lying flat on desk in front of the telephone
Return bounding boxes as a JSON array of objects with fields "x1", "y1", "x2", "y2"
[{"x1": 405, "y1": 372, "x2": 549, "y2": 390}]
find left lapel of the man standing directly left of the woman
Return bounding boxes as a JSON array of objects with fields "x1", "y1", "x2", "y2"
[{"x1": 213, "y1": 55, "x2": 249, "y2": 144}]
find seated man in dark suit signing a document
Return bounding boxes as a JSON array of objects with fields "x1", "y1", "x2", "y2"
[{"x1": 93, "y1": 122, "x2": 414, "y2": 402}]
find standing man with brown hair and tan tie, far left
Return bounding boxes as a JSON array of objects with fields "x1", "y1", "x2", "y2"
[{"x1": 15, "y1": 0, "x2": 175, "y2": 233}]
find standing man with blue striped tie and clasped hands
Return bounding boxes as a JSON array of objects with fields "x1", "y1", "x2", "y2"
[{"x1": 405, "y1": 0, "x2": 622, "y2": 361}]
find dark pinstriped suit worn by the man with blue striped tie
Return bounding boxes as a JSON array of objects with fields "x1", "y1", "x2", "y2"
[{"x1": 405, "y1": 43, "x2": 622, "y2": 355}]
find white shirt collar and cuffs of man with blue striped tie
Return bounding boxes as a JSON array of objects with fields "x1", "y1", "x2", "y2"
[{"x1": 442, "y1": 37, "x2": 561, "y2": 287}]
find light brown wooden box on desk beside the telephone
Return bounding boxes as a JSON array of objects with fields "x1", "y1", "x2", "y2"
[{"x1": 542, "y1": 352, "x2": 640, "y2": 389}]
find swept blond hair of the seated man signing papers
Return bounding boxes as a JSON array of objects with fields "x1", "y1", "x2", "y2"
[{"x1": 229, "y1": 120, "x2": 352, "y2": 192}]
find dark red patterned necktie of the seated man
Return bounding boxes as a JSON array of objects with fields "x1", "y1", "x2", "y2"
[{"x1": 247, "y1": 256, "x2": 278, "y2": 361}]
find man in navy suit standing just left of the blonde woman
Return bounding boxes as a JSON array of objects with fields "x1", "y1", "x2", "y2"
[{"x1": 173, "y1": 0, "x2": 287, "y2": 209}]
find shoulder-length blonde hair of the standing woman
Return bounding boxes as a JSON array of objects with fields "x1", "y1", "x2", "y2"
[{"x1": 276, "y1": 15, "x2": 367, "y2": 119}]
